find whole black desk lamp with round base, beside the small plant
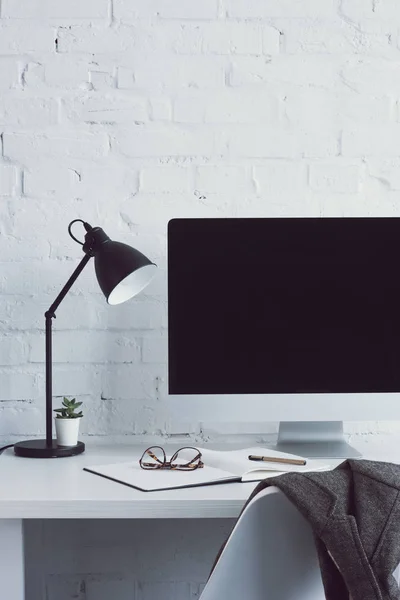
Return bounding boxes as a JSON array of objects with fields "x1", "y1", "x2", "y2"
[{"x1": 14, "y1": 219, "x2": 156, "y2": 458}]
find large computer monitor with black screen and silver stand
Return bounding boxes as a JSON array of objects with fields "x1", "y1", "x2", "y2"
[{"x1": 168, "y1": 218, "x2": 400, "y2": 458}]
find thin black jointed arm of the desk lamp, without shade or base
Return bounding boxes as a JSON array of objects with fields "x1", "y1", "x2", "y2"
[{"x1": 44, "y1": 253, "x2": 93, "y2": 446}]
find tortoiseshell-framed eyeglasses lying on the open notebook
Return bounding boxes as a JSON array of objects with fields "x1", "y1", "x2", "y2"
[{"x1": 139, "y1": 446, "x2": 204, "y2": 471}]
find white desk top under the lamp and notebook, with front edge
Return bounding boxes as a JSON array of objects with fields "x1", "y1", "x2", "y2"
[{"x1": 0, "y1": 443, "x2": 394, "y2": 519}]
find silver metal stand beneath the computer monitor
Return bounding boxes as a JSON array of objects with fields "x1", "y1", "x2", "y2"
[{"x1": 276, "y1": 421, "x2": 361, "y2": 458}]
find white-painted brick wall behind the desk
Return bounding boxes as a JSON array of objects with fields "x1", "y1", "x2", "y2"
[{"x1": 0, "y1": 0, "x2": 400, "y2": 600}]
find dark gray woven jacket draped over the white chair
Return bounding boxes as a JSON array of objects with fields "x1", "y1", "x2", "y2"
[{"x1": 214, "y1": 460, "x2": 400, "y2": 600}]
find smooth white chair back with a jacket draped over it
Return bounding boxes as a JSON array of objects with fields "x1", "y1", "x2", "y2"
[{"x1": 200, "y1": 487, "x2": 325, "y2": 600}]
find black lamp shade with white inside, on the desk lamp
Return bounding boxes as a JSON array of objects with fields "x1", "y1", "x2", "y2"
[{"x1": 94, "y1": 239, "x2": 157, "y2": 304}]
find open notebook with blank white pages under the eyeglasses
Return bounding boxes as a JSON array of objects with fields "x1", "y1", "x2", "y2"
[{"x1": 84, "y1": 447, "x2": 331, "y2": 492}]
